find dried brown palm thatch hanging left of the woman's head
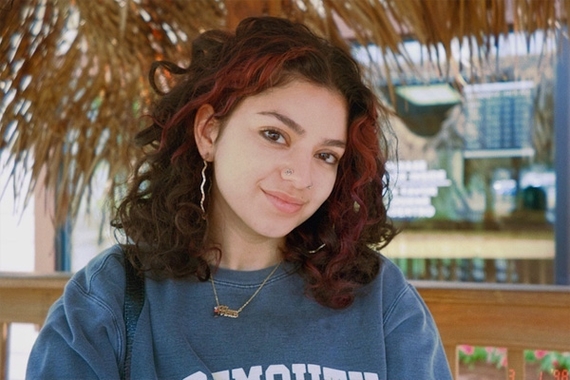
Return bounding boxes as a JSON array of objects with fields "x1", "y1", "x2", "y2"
[{"x1": 0, "y1": 0, "x2": 223, "y2": 222}]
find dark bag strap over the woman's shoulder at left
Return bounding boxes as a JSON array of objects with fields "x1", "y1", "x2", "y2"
[{"x1": 121, "y1": 249, "x2": 145, "y2": 380}]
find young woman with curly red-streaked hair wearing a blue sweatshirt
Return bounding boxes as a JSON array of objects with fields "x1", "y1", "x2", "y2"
[{"x1": 27, "y1": 18, "x2": 451, "y2": 380}]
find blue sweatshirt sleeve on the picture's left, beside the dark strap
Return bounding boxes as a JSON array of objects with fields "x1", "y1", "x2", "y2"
[{"x1": 26, "y1": 251, "x2": 125, "y2": 379}]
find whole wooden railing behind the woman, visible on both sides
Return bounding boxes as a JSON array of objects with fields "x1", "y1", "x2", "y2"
[{"x1": 0, "y1": 273, "x2": 570, "y2": 380}]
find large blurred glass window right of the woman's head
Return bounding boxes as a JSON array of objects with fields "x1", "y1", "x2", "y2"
[{"x1": 354, "y1": 34, "x2": 556, "y2": 283}]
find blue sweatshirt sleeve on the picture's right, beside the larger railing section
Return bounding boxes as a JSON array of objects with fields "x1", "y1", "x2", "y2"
[{"x1": 384, "y1": 283, "x2": 452, "y2": 380}]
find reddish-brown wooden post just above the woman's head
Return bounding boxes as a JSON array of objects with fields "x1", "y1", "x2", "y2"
[{"x1": 226, "y1": 0, "x2": 291, "y2": 30}]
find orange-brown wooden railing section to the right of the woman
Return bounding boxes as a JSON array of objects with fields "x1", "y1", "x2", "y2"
[{"x1": 413, "y1": 281, "x2": 570, "y2": 380}]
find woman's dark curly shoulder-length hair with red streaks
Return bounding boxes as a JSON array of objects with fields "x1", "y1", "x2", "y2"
[{"x1": 113, "y1": 17, "x2": 397, "y2": 308}]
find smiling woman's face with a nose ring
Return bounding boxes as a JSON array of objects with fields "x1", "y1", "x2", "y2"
[{"x1": 204, "y1": 80, "x2": 348, "y2": 242}]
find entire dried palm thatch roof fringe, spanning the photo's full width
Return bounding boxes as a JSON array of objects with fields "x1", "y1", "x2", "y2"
[{"x1": 0, "y1": 0, "x2": 570, "y2": 221}]
